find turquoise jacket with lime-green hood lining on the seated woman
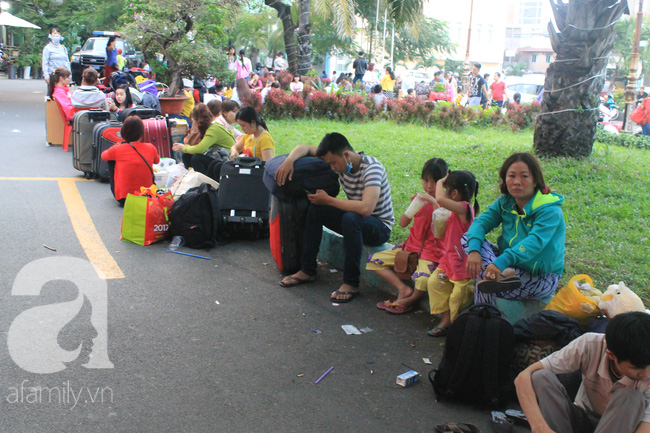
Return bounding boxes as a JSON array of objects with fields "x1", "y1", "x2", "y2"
[{"x1": 467, "y1": 191, "x2": 565, "y2": 276}]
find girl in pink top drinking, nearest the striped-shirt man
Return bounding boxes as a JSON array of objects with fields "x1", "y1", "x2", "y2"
[{"x1": 366, "y1": 158, "x2": 449, "y2": 314}]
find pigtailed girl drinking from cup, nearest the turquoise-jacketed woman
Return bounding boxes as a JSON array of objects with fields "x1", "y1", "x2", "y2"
[{"x1": 427, "y1": 170, "x2": 479, "y2": 337}]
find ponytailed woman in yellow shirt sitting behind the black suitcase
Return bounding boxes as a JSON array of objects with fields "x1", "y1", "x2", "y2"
[{"x1": 230, "y1": 106, "x2": 275, "y2": 161}]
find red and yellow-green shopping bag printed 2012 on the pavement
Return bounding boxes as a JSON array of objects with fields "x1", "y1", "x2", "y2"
[{"x1": 122, "y1": 185, "x2": 174, "y2": 245}]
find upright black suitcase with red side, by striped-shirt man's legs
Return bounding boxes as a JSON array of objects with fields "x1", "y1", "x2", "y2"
[{"x1": 269, "y1": 196, "x2": 309, "y2": 274}]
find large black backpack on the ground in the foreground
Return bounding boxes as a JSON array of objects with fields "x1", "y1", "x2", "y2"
[{"x1": 429, "y1": 304, "x2": 515, "y2": 408}]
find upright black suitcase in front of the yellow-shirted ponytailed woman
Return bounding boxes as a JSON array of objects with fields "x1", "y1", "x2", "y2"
[{"x1": 219, "y1": 156, "x2": 271, "y2": 238}]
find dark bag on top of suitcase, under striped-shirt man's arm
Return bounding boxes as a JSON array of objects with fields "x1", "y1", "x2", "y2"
[{"x1": 264, "y1": 155, "x2": 340, "y2": 200}]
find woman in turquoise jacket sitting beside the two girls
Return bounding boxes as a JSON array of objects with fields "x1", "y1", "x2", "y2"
[{"x1": 466, "y1": 153, "x2": 565, "y2": 304}]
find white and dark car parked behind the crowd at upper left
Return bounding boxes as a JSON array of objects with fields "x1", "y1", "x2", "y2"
[{"x1": 70, "y1": 32, "x2": 144, "y2": 84}]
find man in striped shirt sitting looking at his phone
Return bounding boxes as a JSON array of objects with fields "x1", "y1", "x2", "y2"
[{"x1": 275, "y1": 132, "x2": 395, "y2": 303}]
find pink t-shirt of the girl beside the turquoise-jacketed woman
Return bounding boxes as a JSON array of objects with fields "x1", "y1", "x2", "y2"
[{"x1": 438, "y1": 201, "x2": 474, "y2": 281}]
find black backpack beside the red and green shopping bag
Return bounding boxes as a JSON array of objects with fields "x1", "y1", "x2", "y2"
[{"x1": 170, "y1": 183, "x2": 228, "y2": 249}]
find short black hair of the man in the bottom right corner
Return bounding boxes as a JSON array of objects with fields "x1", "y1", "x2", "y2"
[{"x1": 605, "y1": 312, "x2": 650, "y2": 368}]
